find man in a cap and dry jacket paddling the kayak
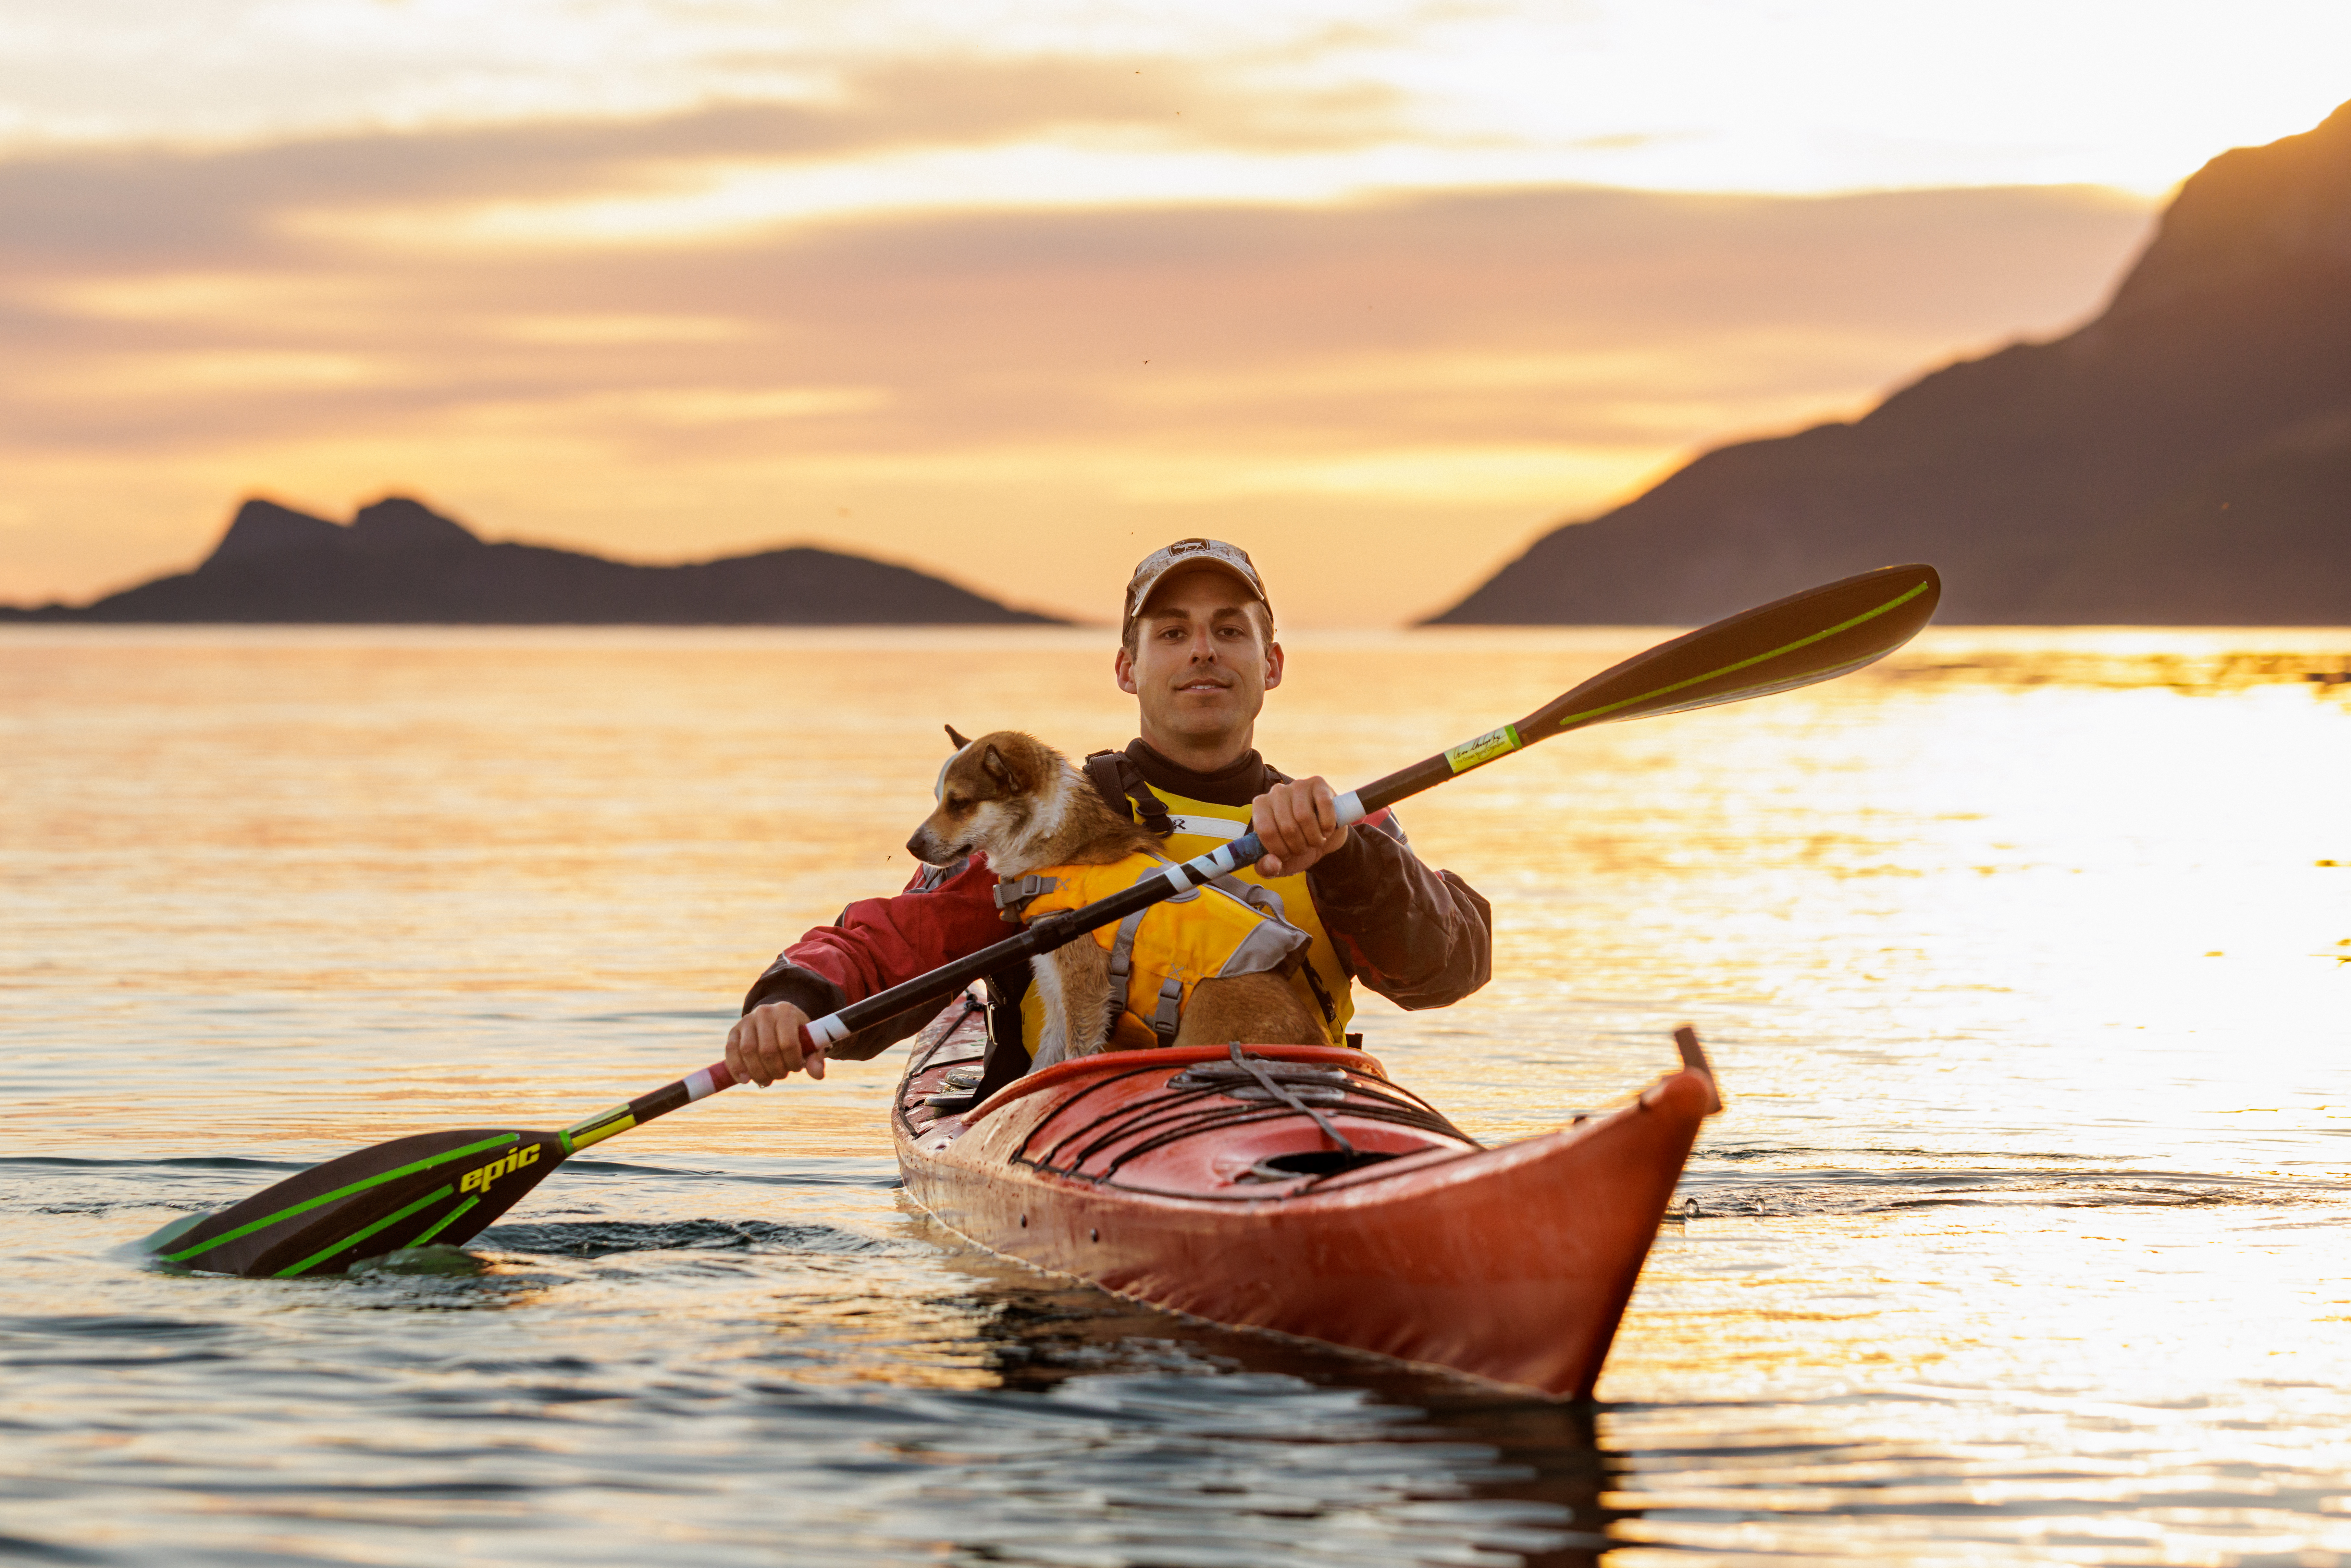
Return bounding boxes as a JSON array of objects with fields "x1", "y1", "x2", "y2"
[{"x1": 726, "y1": 538, "x2": 1493, "y2": 1093}]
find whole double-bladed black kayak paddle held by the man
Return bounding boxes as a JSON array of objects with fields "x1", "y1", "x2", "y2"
[{"x1": 143, "y1": 567, "x2": 1942, "y2": 1279}]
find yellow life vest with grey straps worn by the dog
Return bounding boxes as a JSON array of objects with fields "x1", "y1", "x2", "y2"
[{"x1": 997, "y1": 853, "x2": 1312, "y2": 1067}]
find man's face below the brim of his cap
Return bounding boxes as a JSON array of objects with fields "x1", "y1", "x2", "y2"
[{"x1": 1117, "y1": 569, "x2": 1281, "y2": 745}]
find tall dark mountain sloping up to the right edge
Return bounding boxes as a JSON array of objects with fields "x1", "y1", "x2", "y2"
[{"x1": 1432, "y1": 104, "x2": 2351, "y2": 625}]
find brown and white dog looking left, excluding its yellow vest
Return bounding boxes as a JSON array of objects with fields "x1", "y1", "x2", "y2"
[{"x1": 905, "y1": 726, "x2": 1328, "y2": 1067}]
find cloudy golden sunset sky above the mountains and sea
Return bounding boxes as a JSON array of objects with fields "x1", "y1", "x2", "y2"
[{"x1": 0, "y1": 0, "x2": 2351, "y2": 625}]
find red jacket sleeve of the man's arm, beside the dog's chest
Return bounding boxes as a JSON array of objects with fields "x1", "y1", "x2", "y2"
[{"x1": 743, "y1": 856, "x2": 1013, "y2": 1063}]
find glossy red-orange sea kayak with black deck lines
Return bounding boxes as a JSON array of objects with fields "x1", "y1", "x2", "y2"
[{"x1": 891, "y1": 999, "x2": 1721, "y2": 1399}]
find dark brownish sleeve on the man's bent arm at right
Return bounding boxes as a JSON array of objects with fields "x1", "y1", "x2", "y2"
[{"x1": 1307, "y1": 811, "x2": 1493, "y2": 1008}]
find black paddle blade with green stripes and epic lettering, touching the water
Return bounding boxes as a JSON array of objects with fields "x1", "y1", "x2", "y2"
[{"x1": 141, "y1": 1129, "x2": 564, "y2": 1279}]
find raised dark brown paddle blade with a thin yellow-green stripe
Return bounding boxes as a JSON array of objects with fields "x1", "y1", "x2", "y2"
[{"x1": 1516, "y1": 567, "x2": 1942, "y2": 745}]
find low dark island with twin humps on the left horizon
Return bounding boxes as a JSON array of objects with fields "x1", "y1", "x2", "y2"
[{"x1": 0, "y1": 496, "x2": 1056, "y2": 625}]
